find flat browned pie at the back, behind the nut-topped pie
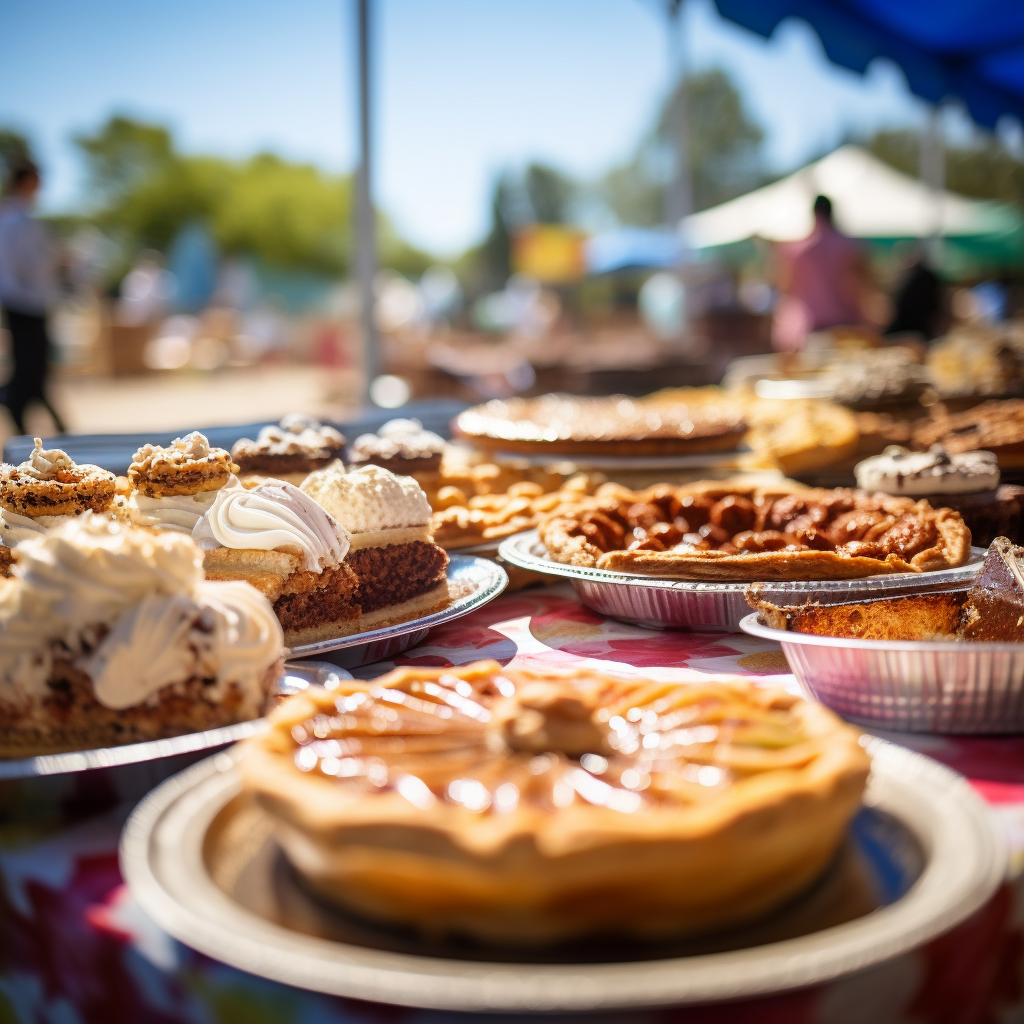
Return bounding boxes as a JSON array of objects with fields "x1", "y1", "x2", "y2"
[{"x1": 455, "y1": 394, "x2": 746, "y2": 456}]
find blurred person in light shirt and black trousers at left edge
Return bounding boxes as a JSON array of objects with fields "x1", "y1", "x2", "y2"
[{"x1": 0, "y1": 160, "x2": 65, "y2": 434}]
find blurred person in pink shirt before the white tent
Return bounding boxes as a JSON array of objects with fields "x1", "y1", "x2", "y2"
[{"x1": 772, "y1": 196, "x2": 870, "y2": 352}]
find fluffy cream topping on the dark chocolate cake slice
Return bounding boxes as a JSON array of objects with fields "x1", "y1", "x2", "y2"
[{"x1": 302, "y1": 466, "x2": 430, "y2": 534}]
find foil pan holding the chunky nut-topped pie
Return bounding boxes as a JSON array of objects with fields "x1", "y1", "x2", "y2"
[{"x1": 499, "y1": 529, "x2": 985, "y2": 631}]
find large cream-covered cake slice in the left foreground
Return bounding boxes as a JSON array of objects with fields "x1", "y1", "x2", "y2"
[{"x1": 0, "y1": 513, "x2": 283, "y2": 757}]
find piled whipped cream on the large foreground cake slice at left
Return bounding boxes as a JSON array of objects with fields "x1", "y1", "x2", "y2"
[{"x1": 0, "y1": 513, "x2": 284, "y2": 714}]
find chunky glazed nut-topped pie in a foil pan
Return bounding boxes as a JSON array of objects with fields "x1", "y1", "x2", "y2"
[{"x1": 540, "y1": 481, "x2": 971, "y2": 581}]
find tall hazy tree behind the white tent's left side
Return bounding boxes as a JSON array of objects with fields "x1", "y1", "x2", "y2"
[{"x1": 599, "y1": 69, "x2": 765, "y2": 224}]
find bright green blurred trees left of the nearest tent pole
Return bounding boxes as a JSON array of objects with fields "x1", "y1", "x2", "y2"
[{"x1": 75, "y1": 117, "x2": 434, "y2": 275}]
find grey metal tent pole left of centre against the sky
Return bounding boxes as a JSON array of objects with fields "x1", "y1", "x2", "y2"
[{"x1": 355, "y1": 0, "x2": 380, "y2": 404}]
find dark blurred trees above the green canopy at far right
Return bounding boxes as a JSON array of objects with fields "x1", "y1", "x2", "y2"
[{"x1": 861, "y1": 128, "x2": 1024, "y2": 212}]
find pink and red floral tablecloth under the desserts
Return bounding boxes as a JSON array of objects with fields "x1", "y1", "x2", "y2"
[{"x1": 0, "y1": 587, "x2": 1024, "y2": 1024}]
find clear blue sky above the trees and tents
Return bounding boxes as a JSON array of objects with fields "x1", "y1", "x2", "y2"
[{"x1": 0, "y1": 0, "x2": 942, "y2": 253}]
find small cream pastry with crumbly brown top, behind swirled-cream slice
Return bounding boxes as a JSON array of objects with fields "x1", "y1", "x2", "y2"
[{"x1": 127, "y1": 430, "x2": 239, "y2": 535}]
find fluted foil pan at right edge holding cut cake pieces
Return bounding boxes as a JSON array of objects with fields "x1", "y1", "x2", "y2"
[{"x1": 739, "y1": 612, "x2": 1024, "y2": 733}]
